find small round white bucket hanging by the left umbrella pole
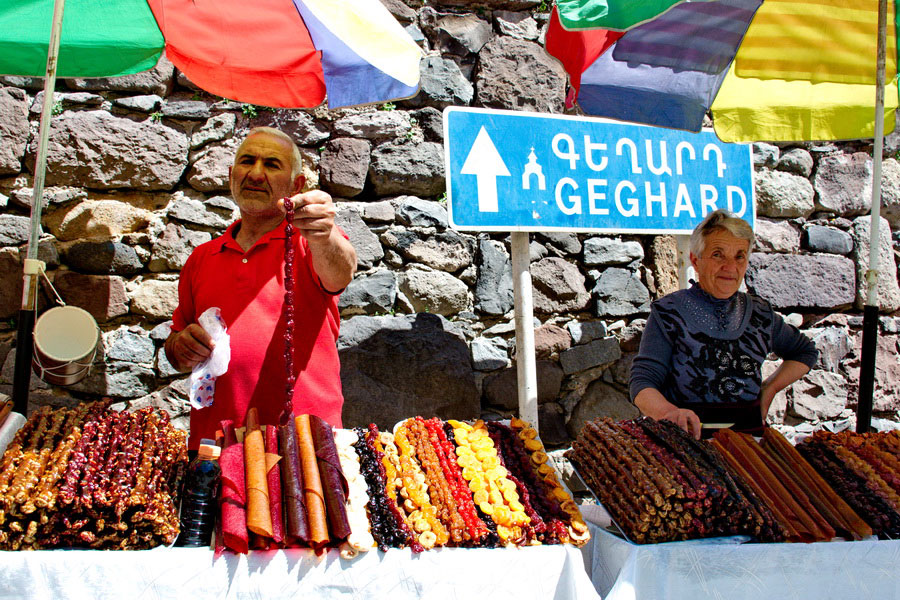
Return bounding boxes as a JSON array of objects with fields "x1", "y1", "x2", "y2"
[{"x1": 31, "y1": 306, "x2": 100, "y2": 385}]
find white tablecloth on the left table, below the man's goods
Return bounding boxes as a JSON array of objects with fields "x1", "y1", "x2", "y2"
[{"x1": 0, "y1": 546, "x2": 599, "y2": 600}]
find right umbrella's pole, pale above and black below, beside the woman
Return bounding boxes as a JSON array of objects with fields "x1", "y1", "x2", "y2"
[{"x1": 856, "y1": 0, "x2": 887, "y2": 433}]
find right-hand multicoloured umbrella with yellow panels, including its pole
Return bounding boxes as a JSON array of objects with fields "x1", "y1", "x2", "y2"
[{"x1": 546, "y1": 0, "x2": 898, "y2": 431}]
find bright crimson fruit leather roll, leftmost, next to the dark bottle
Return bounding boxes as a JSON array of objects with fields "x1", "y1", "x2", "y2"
[{"x1": 219, "y1": 421, "x2": 249, "y2": 554}]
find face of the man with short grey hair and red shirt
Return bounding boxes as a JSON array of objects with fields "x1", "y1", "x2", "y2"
[{"x1": 229, "y1": 133, "x2": 303, "y2": 218}]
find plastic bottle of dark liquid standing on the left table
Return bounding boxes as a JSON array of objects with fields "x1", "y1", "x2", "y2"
[{"x1": 175, "y1": 440, "x2": 222, "y2": 546}]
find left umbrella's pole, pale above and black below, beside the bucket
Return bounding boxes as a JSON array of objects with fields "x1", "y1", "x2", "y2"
[{"x1": 13, "y1": 0, "x2": 66, "y2": 415}]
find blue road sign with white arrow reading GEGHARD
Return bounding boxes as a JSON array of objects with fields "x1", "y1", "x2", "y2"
[{"x1": 444, "y1": 107, "x2": 756, "y2": 234}]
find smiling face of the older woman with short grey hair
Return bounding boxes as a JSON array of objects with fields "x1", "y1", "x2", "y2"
[{"x1": 691, "y1": 229, "x2": 750, "y2": 299}]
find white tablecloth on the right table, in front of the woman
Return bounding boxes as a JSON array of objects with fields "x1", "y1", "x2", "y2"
[{"x1": 585, "y1": 525, "x2": 900, "y2": 600}]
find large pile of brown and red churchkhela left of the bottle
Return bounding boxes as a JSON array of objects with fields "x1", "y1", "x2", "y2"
[{"x1": 0, "y1": 402, "x2": 187, "y2": 550}]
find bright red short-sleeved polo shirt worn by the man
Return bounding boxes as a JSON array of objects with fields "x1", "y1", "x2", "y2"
[{"x1": 172, "y1": 221, "x2": 344, "y2": 449}]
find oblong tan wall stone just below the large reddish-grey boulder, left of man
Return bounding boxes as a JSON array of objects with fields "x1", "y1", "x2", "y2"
[{"x1": 43, "y1": 200, "x2": 153, "y2": 241}]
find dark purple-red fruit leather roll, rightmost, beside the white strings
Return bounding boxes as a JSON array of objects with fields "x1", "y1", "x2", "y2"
[{"x1": 309, "y1": 415, "x2": 350, "y2": 542}]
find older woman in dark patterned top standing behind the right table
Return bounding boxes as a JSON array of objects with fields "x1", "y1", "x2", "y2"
[{"x1": 630, "y1": 210, "x2": 818, "y2": 438}]
